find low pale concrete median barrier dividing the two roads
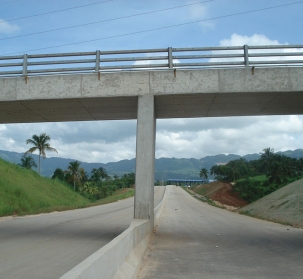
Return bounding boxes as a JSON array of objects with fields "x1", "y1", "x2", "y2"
[{"x1": 60, "y1": 189, "x2": 166, "y2": 279}]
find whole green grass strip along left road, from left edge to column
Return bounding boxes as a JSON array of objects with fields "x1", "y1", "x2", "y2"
[{"x1": 0, "y1": 159, "x2": 134, "y2": 219}]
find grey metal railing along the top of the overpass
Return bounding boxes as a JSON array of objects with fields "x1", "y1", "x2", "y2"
[{"x1": 0, "y1": 45, "x2": 303, "y2": 77}]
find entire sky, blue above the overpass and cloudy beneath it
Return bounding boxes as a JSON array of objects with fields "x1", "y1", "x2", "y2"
[{"x1": 0, "y1": 0, "x2": 303, "y2": 163}]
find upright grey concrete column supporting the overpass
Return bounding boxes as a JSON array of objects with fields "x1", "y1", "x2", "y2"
[{"x1": 134, "y1": 95, "x2": 156, "y2": 229}]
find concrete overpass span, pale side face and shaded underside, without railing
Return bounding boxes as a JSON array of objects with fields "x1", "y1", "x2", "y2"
[{"x1": 0, "y1": 67, "x2": 303, "y2": 123}]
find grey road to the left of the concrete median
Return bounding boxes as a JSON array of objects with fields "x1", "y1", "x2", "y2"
[{"x1": 0, "y1": 187, "x2": 164, "y2": 279}]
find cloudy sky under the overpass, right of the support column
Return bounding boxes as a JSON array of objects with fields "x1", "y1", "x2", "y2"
[{"x1": 156, "y1": 115, "x2": 303, "y2": 158}]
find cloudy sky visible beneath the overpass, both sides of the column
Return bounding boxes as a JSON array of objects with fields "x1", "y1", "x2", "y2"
[{"x1": 0, "y1": 115, "x2": 303, "y2": 163}]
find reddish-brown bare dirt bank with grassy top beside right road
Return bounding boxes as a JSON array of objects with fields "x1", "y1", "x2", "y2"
[{"x1": 193, "y1": 181, "x2": 248, "y2": 209}]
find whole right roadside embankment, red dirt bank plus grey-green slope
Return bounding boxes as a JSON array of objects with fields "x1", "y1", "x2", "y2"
[{"x1": 193, "y1": 179, "x2": 303, "y2": 228}]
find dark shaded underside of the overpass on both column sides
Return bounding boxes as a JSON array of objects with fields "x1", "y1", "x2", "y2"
[{"x1": 0, "y1": 92, "x2": 303, "y2": 123}]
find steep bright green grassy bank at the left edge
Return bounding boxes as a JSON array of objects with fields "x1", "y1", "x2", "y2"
[{"x1": 0, "y1": 159, "x2": 89, "y2": 216}]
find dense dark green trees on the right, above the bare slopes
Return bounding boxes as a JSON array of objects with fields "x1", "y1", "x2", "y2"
[{"x1": 210, "y1": 148, "x2": 303, "y2": 202}]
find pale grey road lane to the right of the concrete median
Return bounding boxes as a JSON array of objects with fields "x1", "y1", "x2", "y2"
[{"x1": 138, "y1": 186, "x2": 303, "y2": 279}]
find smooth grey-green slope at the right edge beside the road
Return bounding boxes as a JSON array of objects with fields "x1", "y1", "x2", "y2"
[{"x1": 239, "y1": 179, "x2": 303, "y2": 227}]
